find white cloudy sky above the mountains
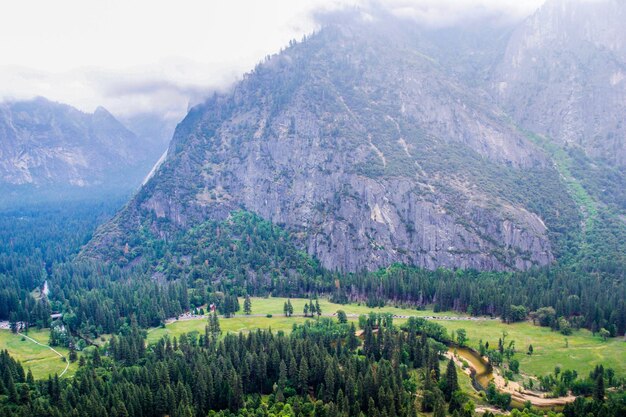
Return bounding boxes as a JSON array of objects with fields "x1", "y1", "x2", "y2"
[{"x1": 0, "y1": 0, "x2": 543, "y2": 119}]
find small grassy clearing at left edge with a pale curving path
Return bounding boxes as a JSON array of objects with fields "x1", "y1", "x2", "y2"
[{"x1": 0, "y1": 329, "x2": 77, "y2": 378}]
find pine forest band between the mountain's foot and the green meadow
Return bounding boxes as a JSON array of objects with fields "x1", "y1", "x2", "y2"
[{"x1": 0, "y1": 205, "x2": 626, "y2": 337}]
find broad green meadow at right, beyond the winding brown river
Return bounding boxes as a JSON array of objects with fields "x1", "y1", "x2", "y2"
[{"x1": 438, "y1": 321, "x2": 626, "y2": 376}]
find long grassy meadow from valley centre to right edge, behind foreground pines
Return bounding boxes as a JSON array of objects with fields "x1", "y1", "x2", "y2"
[{"x1": 148, "y1": 298, "x2": 626, "y2": 376}]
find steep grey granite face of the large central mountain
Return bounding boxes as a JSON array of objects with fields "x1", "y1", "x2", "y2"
[{"x1": 84, "y1": 24, "x2": 566, "y2": 271}]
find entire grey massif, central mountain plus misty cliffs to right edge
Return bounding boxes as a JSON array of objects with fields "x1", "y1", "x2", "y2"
[{"x1": 77, "y1": 1, "x2": 626, "y2": 271}]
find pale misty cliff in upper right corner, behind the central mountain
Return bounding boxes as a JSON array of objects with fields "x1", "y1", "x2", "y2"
[{"x1": 492, "y1": 0, "x2": 626, "y2": 167}]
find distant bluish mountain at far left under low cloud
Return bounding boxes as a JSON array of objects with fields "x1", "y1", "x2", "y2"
[{"x1": 0, "y1": 98, "x2": 163, "y2": 200}]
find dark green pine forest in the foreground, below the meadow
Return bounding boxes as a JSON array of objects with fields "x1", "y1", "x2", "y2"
[{"x1": 0, "y1": 315, "x2": 626, "y2": 417}]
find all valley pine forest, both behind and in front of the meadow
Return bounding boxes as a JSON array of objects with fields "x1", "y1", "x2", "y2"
[{"x1": 0, "y1": 202, "x2": 626, "y2": 417}]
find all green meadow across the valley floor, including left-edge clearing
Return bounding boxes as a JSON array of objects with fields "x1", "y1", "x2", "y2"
[{"x1": 0, "y1": 292, "x2": 626, "y2": 378}]
